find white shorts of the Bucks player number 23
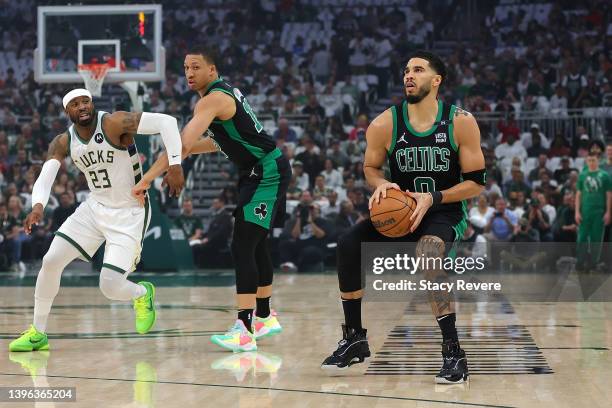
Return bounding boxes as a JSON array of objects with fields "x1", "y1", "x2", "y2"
[{"x1": 55, "y1": 197, "x2": 151, "y2": 273}]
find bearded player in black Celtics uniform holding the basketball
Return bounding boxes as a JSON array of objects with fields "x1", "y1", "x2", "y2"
[{"x1": 322, "y1": 51, "x2": 485, "y2": 383}]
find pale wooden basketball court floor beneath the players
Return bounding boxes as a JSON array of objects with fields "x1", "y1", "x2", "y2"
[{"x1": 0, "y1": 274, "x2": 612, "y2": 408}]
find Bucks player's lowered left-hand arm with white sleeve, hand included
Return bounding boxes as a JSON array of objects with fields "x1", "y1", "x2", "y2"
[{"x1": 23, "y1": 133, "x2": 68, "y2": 234}]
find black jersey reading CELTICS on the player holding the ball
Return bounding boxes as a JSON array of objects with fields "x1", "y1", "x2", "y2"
[{"x1": 388, "y1": 100, "x2": 466, "y2": 219}]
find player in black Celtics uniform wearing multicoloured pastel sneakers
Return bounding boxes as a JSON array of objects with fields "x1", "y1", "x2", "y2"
[{"x1": 133, "y1": 47, "x2": 291, "y2": 351}]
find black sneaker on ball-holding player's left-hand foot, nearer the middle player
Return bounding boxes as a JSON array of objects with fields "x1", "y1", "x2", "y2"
[{"x1": 321, "y1": 325, "x2": 370, "y2": 370}]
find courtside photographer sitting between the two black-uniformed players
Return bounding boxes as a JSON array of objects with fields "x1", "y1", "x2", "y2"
[{"x1": 279, "y1": 198, "x2": 332, "y2": 272}]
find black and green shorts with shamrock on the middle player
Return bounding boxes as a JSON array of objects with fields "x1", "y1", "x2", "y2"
[{"x1": 234, "y1": 149, "x2": 291, "y2": 230}]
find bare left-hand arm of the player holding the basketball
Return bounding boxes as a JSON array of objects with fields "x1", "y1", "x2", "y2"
[{"x1": 363, "y1": 110, "x2": 401, "y2": 209}]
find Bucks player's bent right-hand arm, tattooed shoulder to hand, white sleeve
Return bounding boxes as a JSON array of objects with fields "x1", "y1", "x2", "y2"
[{"x1": 106, "y1": 111, "x2": 185, "y2": 196}]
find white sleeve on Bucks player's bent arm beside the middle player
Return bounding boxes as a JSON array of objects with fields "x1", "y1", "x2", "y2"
[{"x1": 137, "y1": 112, "x2": 183, "y2": 166}]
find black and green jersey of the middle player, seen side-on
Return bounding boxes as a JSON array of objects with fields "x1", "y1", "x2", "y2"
[{"x1": 204, "y1": 79, "x2": 276, "y2": 170}]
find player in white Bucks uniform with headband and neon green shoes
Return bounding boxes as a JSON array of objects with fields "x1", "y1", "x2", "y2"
[{"x1": 9, "y1": 89, "x2": 184, "y2": 351}]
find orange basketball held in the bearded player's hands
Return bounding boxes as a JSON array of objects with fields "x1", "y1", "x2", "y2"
[{"x1": 370, "y1": 189, "x2": 416, "y2": 238}]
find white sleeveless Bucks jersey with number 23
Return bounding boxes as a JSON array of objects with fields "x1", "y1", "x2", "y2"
[{"x1": 68, "y1": 112, "x2": 142, "y2": 208}]
